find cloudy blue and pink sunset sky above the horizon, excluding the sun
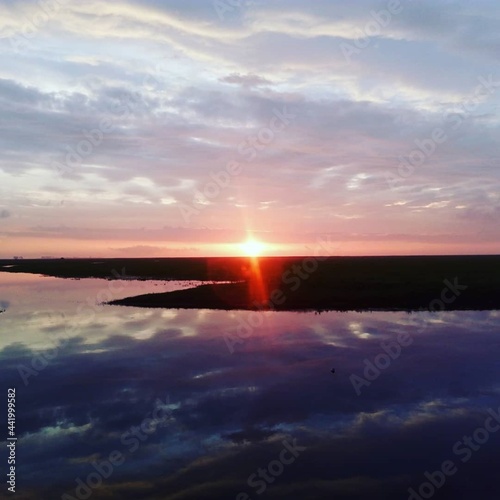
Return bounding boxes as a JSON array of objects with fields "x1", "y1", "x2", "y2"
[{"x1": 0, "y1": 0, "x2": 500, "y2": 258}]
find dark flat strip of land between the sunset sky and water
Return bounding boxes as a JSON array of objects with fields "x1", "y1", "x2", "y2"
[{"x1": 0, "y1": 256, "x2": 500, "y2": 311}]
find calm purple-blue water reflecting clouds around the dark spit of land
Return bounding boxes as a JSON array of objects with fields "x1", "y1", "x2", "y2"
[{"x1": 0, "y1": 273, "x2": 500, "y2": 500}]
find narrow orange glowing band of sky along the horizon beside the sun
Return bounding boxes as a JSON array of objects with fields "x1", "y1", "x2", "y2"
[{"x1": 0, "y1": 235, "x2": 498, "y2": 259}]
